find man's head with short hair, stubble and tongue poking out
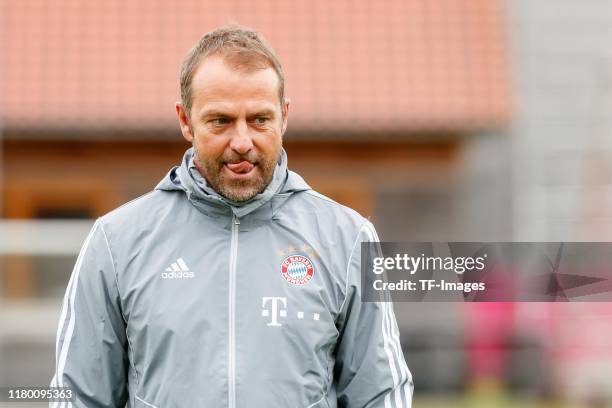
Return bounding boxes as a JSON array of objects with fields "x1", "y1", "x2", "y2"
[{"x1": 176, "y1": 25, "x2": 289, "y2": 201}]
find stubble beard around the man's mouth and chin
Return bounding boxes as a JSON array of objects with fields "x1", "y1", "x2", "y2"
[{"x1": 193, "y1": 145, "x2": 280, "y2": 202}]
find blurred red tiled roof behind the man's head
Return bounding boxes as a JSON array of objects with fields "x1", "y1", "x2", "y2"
[{"x1": 0, "y1": 0, "x2": 509, "y2": 135}]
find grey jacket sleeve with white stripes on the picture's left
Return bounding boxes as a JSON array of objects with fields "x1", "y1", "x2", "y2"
[{"x1": 50, "y1": 220, "x2": 128, "y2": 408}]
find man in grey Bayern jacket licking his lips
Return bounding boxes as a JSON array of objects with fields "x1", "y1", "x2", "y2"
[{"x1": 53, "y1": 26, "x2": 412, "y2": 408}]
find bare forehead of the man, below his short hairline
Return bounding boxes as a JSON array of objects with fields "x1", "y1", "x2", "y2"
[{"x1": 191, "y1": 55, "x2": 280, "y2": 109}]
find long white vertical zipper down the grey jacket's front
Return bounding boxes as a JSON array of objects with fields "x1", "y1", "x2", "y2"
[{"x1": 227, "y1": 214, "x2": 240, "y2": 408}]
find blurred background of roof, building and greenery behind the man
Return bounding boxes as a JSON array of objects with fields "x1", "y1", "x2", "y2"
[{"x1": 0, "y1": 0, "x2": 612, "y2": 408}]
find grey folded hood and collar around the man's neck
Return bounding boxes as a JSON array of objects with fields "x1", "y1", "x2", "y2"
[{"x1": 155, "y1": 147, "x2": 311, "y2": 218}]
